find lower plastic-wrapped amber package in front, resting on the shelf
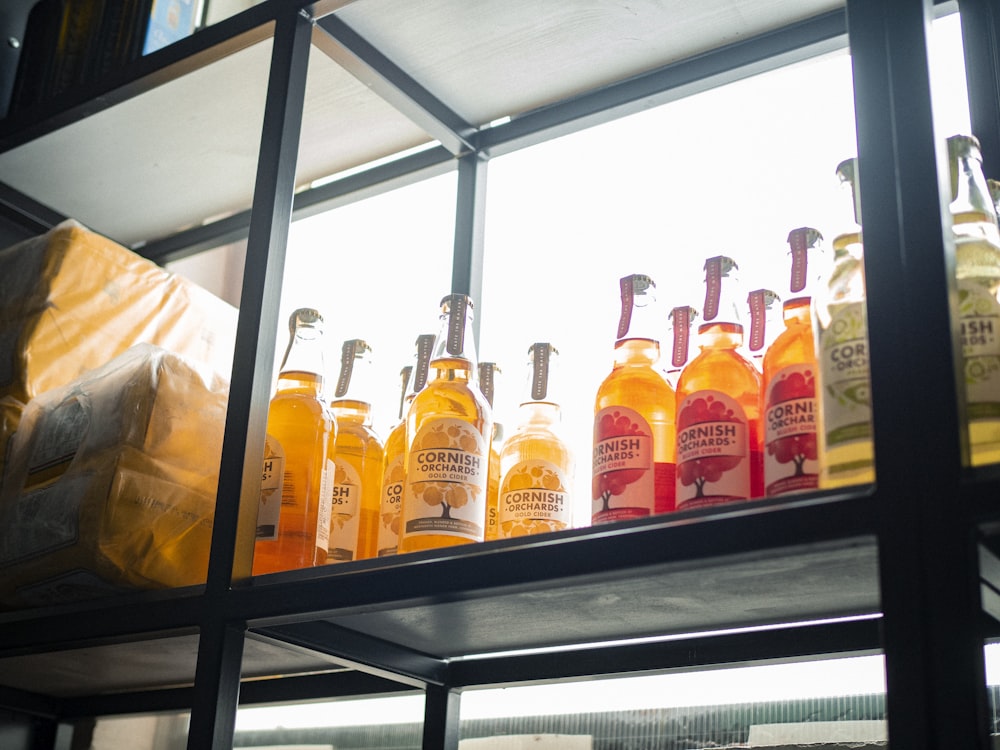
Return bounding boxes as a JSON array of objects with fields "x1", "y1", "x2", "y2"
[{"x1": 0, "y1": 344, "x2": 228, "y2": 607}]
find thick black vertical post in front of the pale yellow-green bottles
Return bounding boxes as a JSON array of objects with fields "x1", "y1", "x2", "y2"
[{"x1": 847, "y1": 0, "x2": 988, "y2": 750}]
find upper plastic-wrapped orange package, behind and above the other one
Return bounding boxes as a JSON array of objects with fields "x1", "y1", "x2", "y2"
[{"x1": 0, "y1": 219, "x2": 238, "y2": 412}]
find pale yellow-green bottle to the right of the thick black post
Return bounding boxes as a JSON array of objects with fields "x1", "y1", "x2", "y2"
[{"x1": 948, "y1": 135, "x2": 1000, "y2": 466}]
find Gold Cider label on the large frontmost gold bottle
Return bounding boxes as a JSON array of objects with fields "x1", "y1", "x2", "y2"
[{"x1": 403, "y1": 417, "x2": 489, "y2": 542}]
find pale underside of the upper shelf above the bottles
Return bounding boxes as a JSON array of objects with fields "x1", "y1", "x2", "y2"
[{"x1": 0, "y1": 0, "x2": 842, "y2": 253}]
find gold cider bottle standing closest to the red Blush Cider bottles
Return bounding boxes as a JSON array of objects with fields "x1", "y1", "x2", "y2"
[{"x1": 499, "y1": 342, "x2": 574, "y2": 539}]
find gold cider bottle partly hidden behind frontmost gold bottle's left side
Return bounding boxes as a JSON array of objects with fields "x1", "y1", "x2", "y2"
[{"x1": 377, "y1": 333, "x2": 434, "y2": 557}]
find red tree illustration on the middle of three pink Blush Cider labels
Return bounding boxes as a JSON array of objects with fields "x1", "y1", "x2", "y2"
[{"x1": 677, "y1": 395, "x2": 745, "y2": 499}]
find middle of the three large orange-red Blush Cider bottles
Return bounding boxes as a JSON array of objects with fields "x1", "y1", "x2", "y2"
[{"x1": 677, "y1": 256, "x2": 764, "y2": 510}]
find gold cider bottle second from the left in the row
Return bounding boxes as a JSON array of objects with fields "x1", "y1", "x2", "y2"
[{"x1": 327, "y1": 339, "x2": 384, "y2": 563}]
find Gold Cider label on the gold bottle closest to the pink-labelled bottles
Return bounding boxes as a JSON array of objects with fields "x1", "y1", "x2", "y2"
[{"x1": 499, "y1": 460, "x2": 572, "y2": 538}]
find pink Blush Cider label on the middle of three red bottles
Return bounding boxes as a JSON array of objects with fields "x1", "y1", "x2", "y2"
[{"x1": 677, "y1": 390, "x2": 751, "y2": 510}]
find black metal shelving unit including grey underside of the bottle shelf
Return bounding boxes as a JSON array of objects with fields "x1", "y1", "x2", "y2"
[{"x1": 0, "y1": 0, "x2": 1000, "y2": 750}]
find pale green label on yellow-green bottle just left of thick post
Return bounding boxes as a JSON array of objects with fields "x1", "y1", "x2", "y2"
[{"x1": 819, "y1": 302, "x2": 871, "y2": 449}]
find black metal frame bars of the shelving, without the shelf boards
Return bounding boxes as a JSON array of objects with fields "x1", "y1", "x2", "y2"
[{"x1": 0, "y1": 0, "x2": 1000, "y2": 750}]
